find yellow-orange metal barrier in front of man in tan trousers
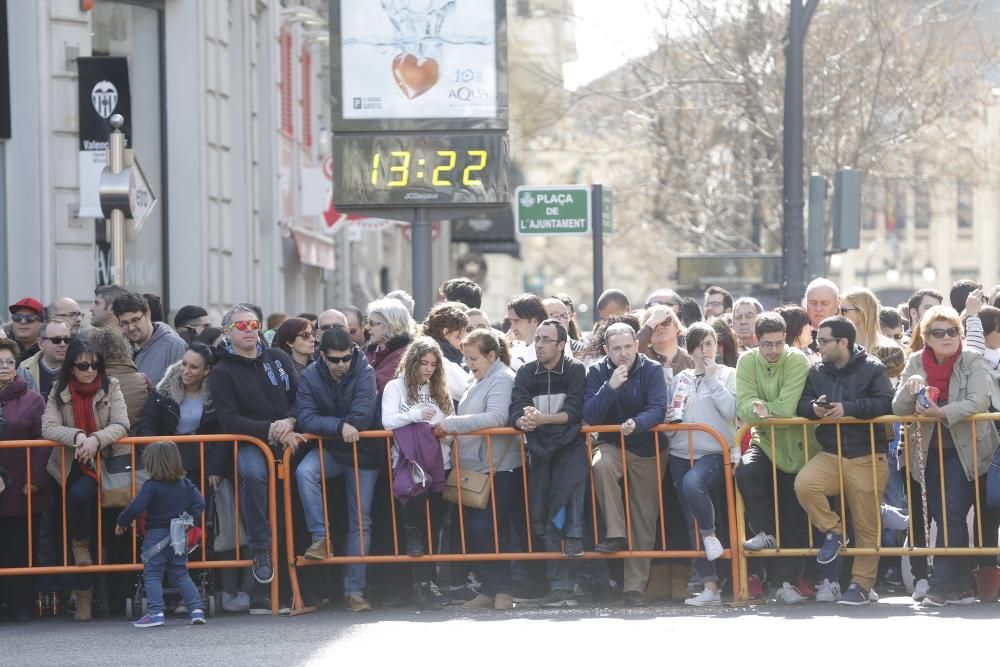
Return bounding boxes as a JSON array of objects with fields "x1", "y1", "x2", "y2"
[{"x1": 735, "y1": 413, "x2": 1000, "y2": 601}]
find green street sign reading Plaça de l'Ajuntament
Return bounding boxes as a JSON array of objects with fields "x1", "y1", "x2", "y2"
[{"x1": 514, "y1": 185, "x2": 590, "y2": 236}]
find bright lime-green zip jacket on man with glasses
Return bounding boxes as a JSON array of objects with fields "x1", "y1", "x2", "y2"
[{"x1": 736, "y1": 347, "x2": 820, "y2": 473}]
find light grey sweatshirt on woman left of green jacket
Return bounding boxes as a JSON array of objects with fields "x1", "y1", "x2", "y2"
[{"x1": 670, "y1": 365, "x2": 736, "y2": 459}]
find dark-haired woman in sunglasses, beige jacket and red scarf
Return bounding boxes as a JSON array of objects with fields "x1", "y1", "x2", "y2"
[{"x1": 42, "y1": 339, "x2": 131, "y2": 621}]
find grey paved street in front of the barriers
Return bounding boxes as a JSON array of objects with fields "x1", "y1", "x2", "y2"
[{"x1": 0, "y1": 598, "x2": 1000, "y2": 667}]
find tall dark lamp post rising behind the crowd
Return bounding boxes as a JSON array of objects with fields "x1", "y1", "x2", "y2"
[{"x1": 781, "y1": 0, "x2": 819, "y2": 301}]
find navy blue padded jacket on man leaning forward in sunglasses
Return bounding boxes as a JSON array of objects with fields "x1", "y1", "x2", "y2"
[{"x1": 296, "y1": 346, "x2": 386, "y2": 469}]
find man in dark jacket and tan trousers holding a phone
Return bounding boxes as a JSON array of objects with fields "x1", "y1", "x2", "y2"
[{"x1": 795, "y1": 316, "x2": 893, "y2": 605}]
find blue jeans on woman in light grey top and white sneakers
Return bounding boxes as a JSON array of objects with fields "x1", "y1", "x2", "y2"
[{"x1": 670, "y1": 454, "x2": 725, "y2": 581}]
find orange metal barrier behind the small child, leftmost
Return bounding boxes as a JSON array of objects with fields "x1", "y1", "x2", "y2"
[{"x1": 0, "y1": 434, "x2": 278, "y2": 615}]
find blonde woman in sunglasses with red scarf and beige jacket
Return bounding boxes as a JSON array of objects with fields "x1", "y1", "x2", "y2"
[{"x1": 892, "y1": 306, "x2": 1000, "y2": 607}]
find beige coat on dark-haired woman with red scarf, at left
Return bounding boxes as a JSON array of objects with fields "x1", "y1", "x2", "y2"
[{"x1": 42, "y1": 378, "x2": 131, "y2": 484}]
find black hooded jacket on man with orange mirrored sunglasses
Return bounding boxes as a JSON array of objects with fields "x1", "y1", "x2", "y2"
[{"x1": 208, "y1": 342, "x2": 299, "y2": 442}]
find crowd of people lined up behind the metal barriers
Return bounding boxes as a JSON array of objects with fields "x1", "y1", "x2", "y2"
[{"x1": 0, "y1": 278, "x2": 1000, "y2": 627}]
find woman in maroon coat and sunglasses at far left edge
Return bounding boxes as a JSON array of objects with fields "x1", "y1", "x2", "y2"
[{"x1": 0, "y1": 340, "x2": 52, "y2": 621}]
